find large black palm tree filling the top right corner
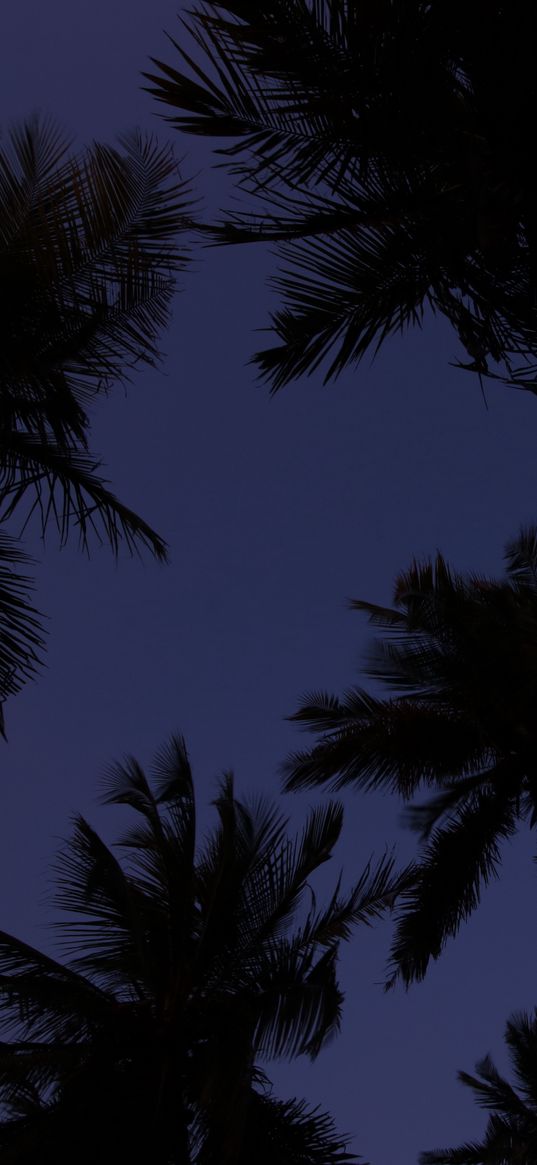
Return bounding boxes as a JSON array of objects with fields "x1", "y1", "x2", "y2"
[{"x1": 146, "y1": 0, "x2": 537, "y2": 390}]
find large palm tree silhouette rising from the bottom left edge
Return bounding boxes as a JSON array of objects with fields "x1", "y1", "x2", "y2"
[{"x1": 0, "y1": 737, "x2": 409, "y2": 1165}]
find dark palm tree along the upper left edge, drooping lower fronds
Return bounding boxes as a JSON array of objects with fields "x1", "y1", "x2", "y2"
[{"x1": 0, "y1": 119, "x2": 189, "y2": 717}]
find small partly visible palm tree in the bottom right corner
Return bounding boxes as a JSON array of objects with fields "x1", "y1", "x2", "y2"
[{"x1": 419, "y1": 1012, "x2": 537, "y2": 1165}]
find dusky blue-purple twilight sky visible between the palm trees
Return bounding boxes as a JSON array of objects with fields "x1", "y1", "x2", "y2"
[{"x1": 0, "y1": 0, "x2": 537, "y2": 1165}]
